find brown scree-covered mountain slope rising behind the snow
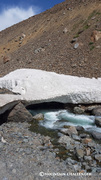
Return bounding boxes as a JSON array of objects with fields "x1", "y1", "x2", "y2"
[{"x1": 0, "y1": 0, "x2": 101, "y2": 77}]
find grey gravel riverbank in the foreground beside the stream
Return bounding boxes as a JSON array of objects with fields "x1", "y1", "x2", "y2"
[{"x1": 0, "y1": 119, "x2": 101, "y2": 180}]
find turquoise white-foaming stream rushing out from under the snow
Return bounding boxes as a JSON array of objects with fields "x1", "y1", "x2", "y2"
[{"x1": 31, "y1": 109, "x2": 101, "y2": 132}]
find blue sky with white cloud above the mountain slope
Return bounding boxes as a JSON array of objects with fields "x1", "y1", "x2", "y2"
[{"x1": 0, "y1": 0, "x2": 64, "y2": 31}]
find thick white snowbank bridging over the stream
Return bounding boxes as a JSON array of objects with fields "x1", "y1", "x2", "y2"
[{"x1": 0, "y1": 69, "x2": 101, "y2": 113}]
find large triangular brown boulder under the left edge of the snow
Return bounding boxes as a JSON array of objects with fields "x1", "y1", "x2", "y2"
[{"x1": 7, "y1": 102, "x2": 33, "y2": 122}]
